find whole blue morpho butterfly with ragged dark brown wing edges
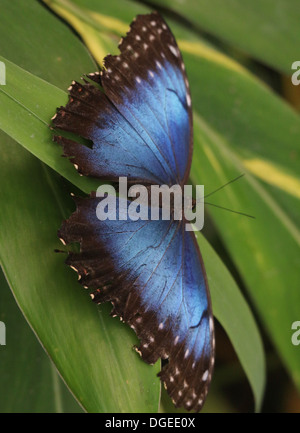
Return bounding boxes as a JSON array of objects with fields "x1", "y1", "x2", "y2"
[{"x1": 53, "y1": 12, "x2": 214, "y2": 411}]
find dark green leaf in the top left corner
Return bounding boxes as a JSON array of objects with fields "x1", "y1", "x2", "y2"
[{"x1": 0, "y1": 0, "x2": 96, "y2": 89}]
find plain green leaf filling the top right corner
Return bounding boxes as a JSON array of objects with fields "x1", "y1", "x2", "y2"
[{"x1": 142, "y1": 0, "x2": 300, "y2": 75}]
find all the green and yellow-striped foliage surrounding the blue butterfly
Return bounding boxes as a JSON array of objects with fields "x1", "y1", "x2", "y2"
[{"x1": 0, "y1": 0, "x2": 300, "y2": 412}]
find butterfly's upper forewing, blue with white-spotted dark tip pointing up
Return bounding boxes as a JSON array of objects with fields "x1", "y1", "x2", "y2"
[{"x1": 102, "y1": 13, "x2": 192, "y2": 184}]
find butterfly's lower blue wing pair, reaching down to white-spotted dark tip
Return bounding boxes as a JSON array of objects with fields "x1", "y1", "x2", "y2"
[{"x1": 59, "y1": 197, "x2": 214, "y2": 411}]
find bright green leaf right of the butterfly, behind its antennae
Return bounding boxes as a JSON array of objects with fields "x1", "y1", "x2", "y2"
[{"x1": 192, "y1": 116, "x2": 300, "y2": 387}]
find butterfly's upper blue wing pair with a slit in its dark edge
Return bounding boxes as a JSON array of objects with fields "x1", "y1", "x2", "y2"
[{"x1": 53, "y1": 13, "x2": 192, "y2": 185}]
